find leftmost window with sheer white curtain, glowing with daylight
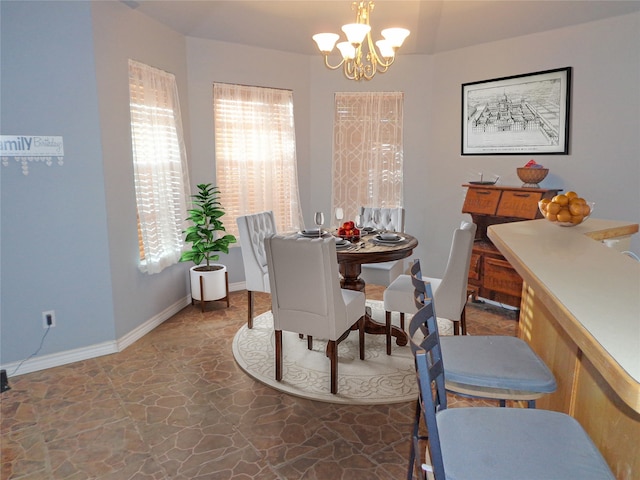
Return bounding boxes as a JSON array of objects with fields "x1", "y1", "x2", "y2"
[{"x1": 129, "y1": 60, "x2": 189, "y2": 274}]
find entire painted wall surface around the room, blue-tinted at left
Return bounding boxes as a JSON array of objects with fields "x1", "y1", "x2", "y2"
[{"x1": 0, "y1": 2, "x2": 640, "y2": 373}]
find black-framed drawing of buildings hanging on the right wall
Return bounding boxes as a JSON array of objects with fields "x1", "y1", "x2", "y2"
[{"x1": 461, "y1": 67, "x2": 571, "y2": 155}]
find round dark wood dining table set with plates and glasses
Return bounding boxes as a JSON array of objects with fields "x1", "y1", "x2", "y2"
[{"x1": 336, "y1": 232, "x2": 418, "y2": 346}]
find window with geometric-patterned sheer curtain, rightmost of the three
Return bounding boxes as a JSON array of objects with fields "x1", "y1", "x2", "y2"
[{"x1": 331, "y1": 92, "x2": 404, "y2": 218}]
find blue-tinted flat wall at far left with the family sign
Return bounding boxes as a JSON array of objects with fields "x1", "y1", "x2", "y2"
[{"x1": 0, "y1": 2, "x2": 114, "y2": 364}]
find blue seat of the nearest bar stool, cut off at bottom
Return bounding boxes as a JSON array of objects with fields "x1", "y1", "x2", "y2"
[{"x1": 436, "y1": 407, "x2": 615, "y2": 480}]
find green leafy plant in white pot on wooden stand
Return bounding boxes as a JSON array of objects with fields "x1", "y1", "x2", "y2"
[{"x1": 180, "y1": 183, "x2": 236, "y2": 309}]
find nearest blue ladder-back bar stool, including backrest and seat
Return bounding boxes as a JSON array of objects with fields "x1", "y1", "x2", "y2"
[{"x1": 407, "y1": 302, "x2": 615, "y2": 480}]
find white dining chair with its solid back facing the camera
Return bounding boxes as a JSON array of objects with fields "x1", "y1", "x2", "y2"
[{"x1": 264, "y1": 235, "x2": 365, "y2": 394}]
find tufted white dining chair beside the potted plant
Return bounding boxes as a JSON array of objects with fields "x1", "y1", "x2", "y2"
[{"x1": 236, "y1": 211, "x2": 276, "y2": 328}]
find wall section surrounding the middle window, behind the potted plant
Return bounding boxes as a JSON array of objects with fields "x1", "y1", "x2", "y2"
[{"x1": 187, "y1": 38, "x2": 315, "y2": 284}]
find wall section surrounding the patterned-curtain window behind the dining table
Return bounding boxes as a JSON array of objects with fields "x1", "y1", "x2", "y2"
[{"x1": 305, "y1": 49, "x2": 440, "y2": 270}]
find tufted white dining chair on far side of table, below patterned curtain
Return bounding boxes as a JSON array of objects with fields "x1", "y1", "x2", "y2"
[{"x1": 360, "y1": 207, "x2": 404, "y2": 287}]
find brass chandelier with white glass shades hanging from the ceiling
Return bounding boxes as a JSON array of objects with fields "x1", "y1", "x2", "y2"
[{"x1": 312, "y1": 1, "x2": 409, "y2": 80}]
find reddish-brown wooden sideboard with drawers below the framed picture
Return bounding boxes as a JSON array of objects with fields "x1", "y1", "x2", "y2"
[{"x1": 462, "y1": 184, "x2": 560, "y2": 307}]
